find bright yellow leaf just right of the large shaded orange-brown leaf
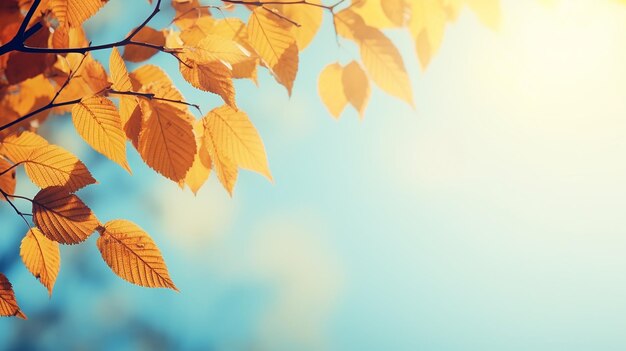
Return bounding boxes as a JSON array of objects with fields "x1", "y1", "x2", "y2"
[{"x1": 204, "y1": 105, "x2": 272, "y2": 180}]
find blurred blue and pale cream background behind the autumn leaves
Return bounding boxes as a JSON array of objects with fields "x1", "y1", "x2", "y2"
[{"x1": 0, "y1": 0, "x2": 626, "y2": 351}]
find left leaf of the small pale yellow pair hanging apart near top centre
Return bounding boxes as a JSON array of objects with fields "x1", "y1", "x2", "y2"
[{"x1": 318, "y1": 63, "x2": 348, "y2": 118}]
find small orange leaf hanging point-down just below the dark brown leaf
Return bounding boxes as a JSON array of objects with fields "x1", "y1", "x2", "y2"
[{"x1": 20, "y1": 228, "x2": 61, "y2": 295}]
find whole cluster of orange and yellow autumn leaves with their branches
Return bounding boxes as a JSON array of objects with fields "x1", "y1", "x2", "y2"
[{"x1": 0, "y1": 0, "x2": 497, "y2": 318}]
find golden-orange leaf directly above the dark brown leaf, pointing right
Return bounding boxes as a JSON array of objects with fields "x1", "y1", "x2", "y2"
[{"x1": 19, "y1": 145, "x2": 96, "y2": 192}]
